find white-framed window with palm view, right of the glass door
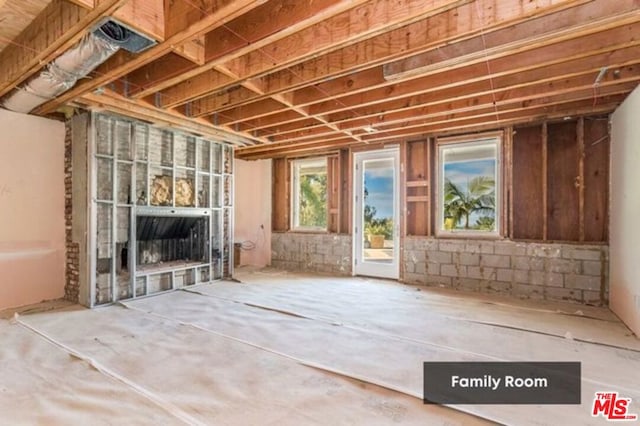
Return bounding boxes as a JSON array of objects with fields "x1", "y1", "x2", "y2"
[{"x1": 437, "y1": 138, "x2": 500, "y2": 235}]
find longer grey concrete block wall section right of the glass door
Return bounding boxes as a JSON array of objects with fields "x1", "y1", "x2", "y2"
[{"x1": 402, "y1": 237, "x2": 609, "y2": 305}]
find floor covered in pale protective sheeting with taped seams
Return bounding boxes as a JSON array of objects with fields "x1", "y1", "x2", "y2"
[{"x1": 0, "y1": 268, "x2": 640, "y2": 425}]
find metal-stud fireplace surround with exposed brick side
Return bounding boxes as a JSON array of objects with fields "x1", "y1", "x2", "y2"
[{"x1": 67, "y1": 113, "x2": 233, "y2": 306}]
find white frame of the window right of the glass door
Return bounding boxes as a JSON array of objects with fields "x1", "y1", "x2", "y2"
[{"x1": 434, "y1": 132, "x2": 505, "y2": 239}]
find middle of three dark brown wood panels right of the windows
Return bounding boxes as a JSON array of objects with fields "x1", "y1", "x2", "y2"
[{"x1": 547, "y1": 121, "x2": 580, "y2": 241}]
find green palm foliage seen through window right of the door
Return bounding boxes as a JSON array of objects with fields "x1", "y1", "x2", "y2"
[{"x1": 444, "y1": 176, "x2": 496, "y2": 231}]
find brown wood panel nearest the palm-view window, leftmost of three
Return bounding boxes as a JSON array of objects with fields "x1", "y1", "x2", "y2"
[{"x1": 512, "y1": 126, "x2": 544, "y2": 240}]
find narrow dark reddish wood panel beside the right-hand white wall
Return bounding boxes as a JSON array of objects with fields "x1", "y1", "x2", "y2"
[{"x1": 584, "y1": 116, "x2": 609, "y2": 241}]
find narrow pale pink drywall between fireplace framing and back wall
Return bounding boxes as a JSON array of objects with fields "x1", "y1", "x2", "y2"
[{"x1": 234, "y1": 160, "x2": 272, "y2": 266}]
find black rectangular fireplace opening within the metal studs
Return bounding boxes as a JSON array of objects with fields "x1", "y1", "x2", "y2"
[{"x1": 136, "y1": 215, "x2": 210, "y2": 272}]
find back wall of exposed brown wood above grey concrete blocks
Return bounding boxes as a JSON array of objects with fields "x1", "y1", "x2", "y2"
[{"x1": 272, "y1": 112, "x2": 609, "y2": 305}]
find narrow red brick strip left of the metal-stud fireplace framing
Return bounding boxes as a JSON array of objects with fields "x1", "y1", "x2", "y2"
[{"x1": 64, "y1": 121, "x2": 80, "y2": 302}]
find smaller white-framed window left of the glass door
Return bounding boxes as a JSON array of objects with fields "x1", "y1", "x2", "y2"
[{"x1": 291, "y1": 158, "x2": 327, "y2": 231}]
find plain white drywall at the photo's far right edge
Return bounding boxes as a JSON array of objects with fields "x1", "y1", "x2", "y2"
[{"x1": 609, "y1": 84, "x2": 640, "y2": 336}]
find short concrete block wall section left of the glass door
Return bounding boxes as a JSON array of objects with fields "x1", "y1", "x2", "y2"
[{"x1": 271, "y1": 232, "x2": 352, "y2": 275}]
